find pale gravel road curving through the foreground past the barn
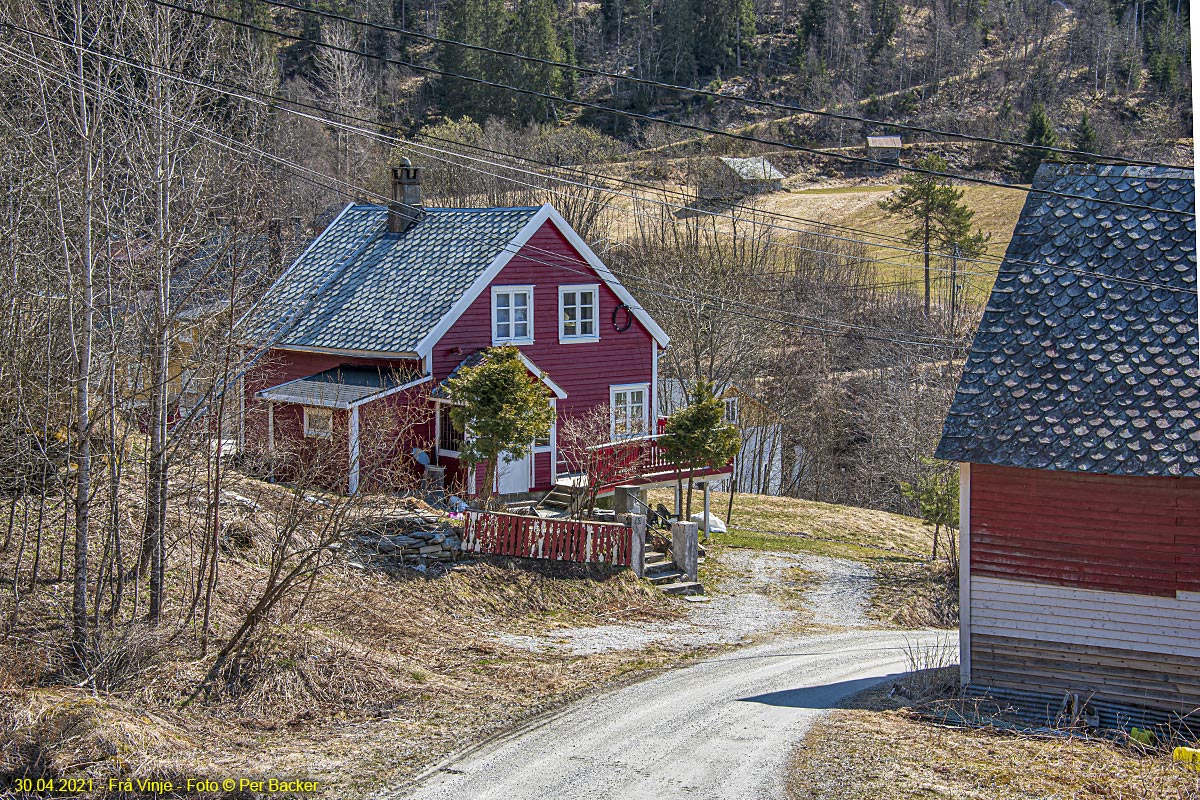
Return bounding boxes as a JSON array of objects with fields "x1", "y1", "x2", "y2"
[{"x1": 400, "y1": 631, "x2": 938, "y2": 800}]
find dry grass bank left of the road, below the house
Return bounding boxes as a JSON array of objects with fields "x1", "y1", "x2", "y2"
[{"x1": 0, "y1": 479, "x2": 686, "y2": 798}]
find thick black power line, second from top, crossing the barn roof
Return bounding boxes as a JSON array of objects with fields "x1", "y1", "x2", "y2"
[{"x1": 142, "y1": 0, "x2": 1195, "y2": 217}]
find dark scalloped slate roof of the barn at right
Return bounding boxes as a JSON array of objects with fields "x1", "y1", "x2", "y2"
[{"x1": 936, "y1": 164, "x2": 1200, "y2": 476}]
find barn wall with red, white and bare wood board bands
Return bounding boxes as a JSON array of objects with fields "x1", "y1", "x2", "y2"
[{"x1": 964, "y1": 464, "x2": 1200, "y2": 714}]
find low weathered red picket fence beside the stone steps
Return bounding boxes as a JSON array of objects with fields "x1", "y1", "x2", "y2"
[{"x1": 462, "y1": 511, "x2": 632, "y2": 566}]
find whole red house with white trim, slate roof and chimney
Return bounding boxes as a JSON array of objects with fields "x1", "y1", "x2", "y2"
[{"x1": 246, "y1": 164, "x2": 686, "y2": 494}]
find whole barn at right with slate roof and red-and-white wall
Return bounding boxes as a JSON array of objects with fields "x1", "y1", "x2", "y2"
[{"x1": 937, "y1": 166, "x2": 1200, "y2": 727}]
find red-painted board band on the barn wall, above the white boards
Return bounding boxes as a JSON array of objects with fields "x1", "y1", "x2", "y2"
[{"x1": 971, "y1": 464, "x2": 1200, "y2": 597}]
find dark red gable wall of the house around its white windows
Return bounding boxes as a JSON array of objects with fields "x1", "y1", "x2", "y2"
[{"x1": 432, "y1": 222, "x2": 654, "y2": 488}]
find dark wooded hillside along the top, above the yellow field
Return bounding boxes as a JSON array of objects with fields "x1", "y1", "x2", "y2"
[{"x1": 267, "y1": 0, "x2": 1192, "y2": 167}]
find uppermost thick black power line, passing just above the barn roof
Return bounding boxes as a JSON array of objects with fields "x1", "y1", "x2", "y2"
[{"x1": 256, "y1": 0, "x2": 1181, "y2": 168}]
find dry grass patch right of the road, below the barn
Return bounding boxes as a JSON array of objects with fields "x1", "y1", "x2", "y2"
[{"x1": 788, "y1": 709, "x2": 1200, "y2": 800}]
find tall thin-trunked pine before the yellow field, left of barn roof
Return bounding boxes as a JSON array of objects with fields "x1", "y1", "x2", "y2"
[{"x1": 880, "y1": 156, "x2": 988, "y2": 319}]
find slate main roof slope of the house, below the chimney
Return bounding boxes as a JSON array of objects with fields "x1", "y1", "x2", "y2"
[{"x1": 247, "y1": 205, "x2": 539, "y2": 353}]
